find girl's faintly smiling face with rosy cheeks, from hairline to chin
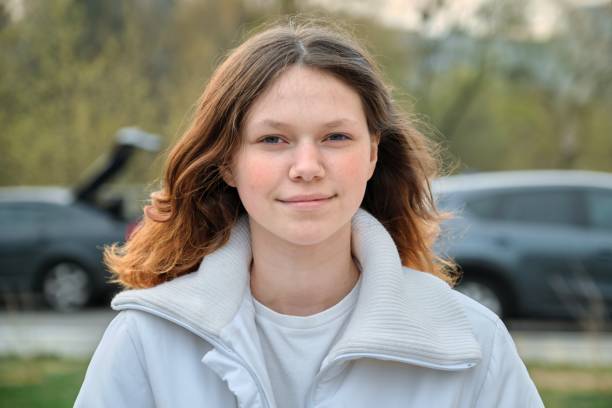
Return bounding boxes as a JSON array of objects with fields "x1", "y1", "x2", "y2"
[{"x1": 224, "y1": 66, "x2": 378, "y2": 245}]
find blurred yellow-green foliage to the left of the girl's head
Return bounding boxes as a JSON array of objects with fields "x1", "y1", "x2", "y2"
[{"x1": 0, "y1": 0, "x2": 260, "y2": 184}]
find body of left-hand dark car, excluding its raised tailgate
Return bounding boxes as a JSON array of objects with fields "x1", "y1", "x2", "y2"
[{"x1": 0, "y1": 188, "x2": 126, "y2": 310}]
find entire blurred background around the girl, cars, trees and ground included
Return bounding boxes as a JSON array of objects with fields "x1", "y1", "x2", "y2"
[{"x1": 0, "y1": 0, "x2": 612, "y2": 407}]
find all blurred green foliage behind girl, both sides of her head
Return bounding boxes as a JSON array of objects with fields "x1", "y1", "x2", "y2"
[{"x1": 0, "y1": 0, "x2": 612, "y2": 185}]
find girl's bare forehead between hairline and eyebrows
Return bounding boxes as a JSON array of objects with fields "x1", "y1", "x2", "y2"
[{"x1": 245, "y1": 66, "x2": 366, "y2": 126}]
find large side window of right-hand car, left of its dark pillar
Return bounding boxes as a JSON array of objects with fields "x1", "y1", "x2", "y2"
[{"x1": 500, "y1": 189, "x2": 580, "y2": 225}]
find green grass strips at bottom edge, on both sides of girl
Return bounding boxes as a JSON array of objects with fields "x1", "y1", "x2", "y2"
[{"x1": 0, "y1": 356, "x2": 612, "y2": 408}]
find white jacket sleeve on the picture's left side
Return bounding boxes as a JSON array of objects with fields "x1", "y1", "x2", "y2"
[{"x1": 74, "y1": 311, "x2": 155, "y2": 408}]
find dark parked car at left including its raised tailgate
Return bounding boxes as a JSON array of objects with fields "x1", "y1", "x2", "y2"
[{"x1": 0, "y1": 128, "x2": 159, "y2": 310}]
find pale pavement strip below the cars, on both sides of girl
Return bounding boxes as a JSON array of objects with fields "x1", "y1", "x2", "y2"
[{"x1": 0, "y1": 309, "x2": 612, "y2": 366}]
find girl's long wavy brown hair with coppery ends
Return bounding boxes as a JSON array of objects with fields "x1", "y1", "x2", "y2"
[{"x1": 104, "y1": 20, "x2": 455, "y2": 288}]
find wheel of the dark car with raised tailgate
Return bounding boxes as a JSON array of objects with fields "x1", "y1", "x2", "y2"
[{"x1": 42, "y1": 261, "x2": 93, "y2": 311}]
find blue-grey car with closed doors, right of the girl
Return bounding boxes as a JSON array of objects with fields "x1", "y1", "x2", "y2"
[{"x1": 433, "y1": 170, "x2": 612, "y2": 319}]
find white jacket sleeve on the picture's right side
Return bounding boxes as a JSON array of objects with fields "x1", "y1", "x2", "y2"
[{"x1": 476, "y1": 321, "x2": 544, "y2": 408}]
